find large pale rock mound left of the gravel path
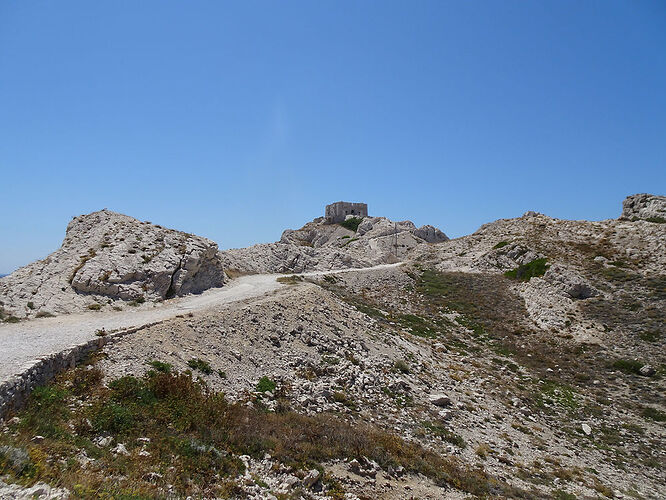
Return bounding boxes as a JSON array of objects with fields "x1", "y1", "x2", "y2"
[{"x1": 0, "y1": 210, "x2": 224, "y2": 318}]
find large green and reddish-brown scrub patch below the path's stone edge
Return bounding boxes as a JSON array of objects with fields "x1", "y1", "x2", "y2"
[{"x1": 0, "y1": 368, "x2": 531, "y2": 498}]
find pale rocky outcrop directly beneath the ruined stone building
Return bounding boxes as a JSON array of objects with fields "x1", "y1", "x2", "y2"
[{"x1": 221, "y1": 217, "x2": 448, "y2": 273}]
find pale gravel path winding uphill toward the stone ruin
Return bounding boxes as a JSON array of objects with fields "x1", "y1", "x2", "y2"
[{"x1": 0, "y1": 263, "x2": 400, "y2": 384}]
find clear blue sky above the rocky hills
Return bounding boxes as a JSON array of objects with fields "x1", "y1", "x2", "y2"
[{"x1": 0, "y1": 0, "x2": 666, "y2": 273}]
